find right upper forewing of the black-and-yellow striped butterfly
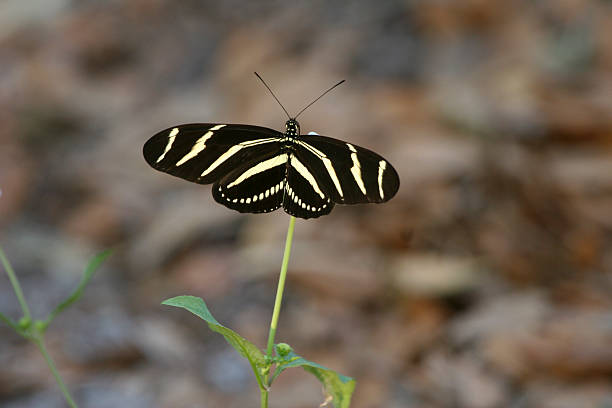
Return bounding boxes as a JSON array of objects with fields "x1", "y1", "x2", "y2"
[{"x1": 295, "y1": 135, "x2": 399, "y2": 204}]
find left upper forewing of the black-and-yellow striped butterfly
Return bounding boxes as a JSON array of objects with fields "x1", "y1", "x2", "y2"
[{"x1": 143, "y1": 123, "x2": 283, "y2": 184}]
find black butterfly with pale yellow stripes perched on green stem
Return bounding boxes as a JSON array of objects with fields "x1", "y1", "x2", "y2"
[{"x1": 143, "y1": 73, "x2": 399, "y2": 218}]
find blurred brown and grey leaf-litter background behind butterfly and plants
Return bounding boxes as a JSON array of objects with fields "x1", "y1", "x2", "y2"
[{"x1": 0, "y1": 0, "x2": 612, "y2": 408}]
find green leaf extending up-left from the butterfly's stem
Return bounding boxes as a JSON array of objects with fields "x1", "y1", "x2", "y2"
[{"x1": 162, "y1": 296, "x2": 269, "y2": 390}]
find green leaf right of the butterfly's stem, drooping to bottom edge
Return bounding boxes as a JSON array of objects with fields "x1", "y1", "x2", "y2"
[{"x1": 270, "y1": 343, "x2": 356, "y2": 408}]
